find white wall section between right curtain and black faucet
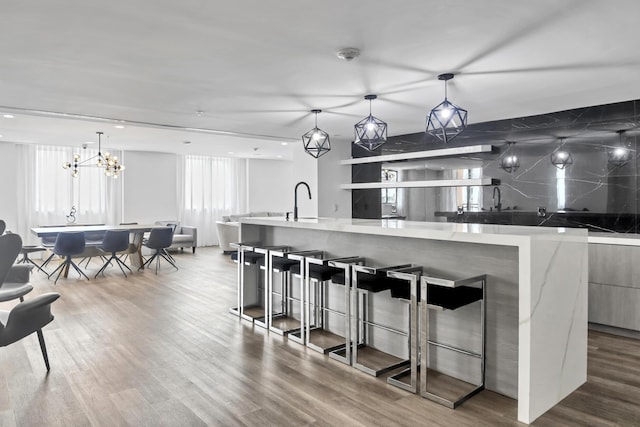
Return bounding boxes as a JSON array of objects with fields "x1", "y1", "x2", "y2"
[{"x1": 248, "y1": 159, "x2": 293, "y2": 213}]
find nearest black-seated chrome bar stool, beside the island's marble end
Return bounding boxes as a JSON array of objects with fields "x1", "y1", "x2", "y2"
[{"x1": 420, "y1": 275, "x2": 486, "y2": 409}]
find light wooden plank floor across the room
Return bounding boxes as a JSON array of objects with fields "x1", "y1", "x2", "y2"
[{"x1": 0, "y1": 248, "x2": 640, "y2": 426}]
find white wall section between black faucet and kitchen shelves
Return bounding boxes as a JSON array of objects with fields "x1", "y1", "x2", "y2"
[{"x1": 318, "y1": 139, "x2": 351, "y2": 218}]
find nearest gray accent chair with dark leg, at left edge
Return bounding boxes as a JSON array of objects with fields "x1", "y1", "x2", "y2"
[{"x1": 0, "y1": 292, "x2": 60, "y2": 371}]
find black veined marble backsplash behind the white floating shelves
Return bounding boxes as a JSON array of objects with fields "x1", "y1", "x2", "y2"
[{"x1": 352, "y1": 101, "x2": 640, "y2": 233}]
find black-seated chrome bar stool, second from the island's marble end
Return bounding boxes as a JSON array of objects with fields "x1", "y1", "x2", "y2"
[{"x1": 387, "y1": 266, "x2": 422, "y2": 393}]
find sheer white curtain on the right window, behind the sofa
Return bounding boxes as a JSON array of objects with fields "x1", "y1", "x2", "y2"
[{"x1": 178, "y1": 156, "x2": 247, "y2": 246}]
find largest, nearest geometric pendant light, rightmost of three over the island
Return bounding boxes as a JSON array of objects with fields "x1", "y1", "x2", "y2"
[{"x1": 427, "y1": 73, "x2": 467, "y2": 143}]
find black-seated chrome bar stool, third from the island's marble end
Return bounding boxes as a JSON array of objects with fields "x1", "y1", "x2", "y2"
[{"x1": 351, "y1": 264, "x2": 414, "y2": 377}]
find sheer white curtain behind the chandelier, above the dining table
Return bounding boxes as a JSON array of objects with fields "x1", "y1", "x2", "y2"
[{"x1": 17, "y1": 145, "x2": 122, "y2": 243}]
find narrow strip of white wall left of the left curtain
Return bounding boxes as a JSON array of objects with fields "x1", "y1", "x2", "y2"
[{"x1": 0, "y1": 142, "x2": 18, "y2": 231}]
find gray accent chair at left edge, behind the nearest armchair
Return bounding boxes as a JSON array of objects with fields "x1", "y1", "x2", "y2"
[{"x1": 0, "y1": 234, "x2": 33, "y2": 302}]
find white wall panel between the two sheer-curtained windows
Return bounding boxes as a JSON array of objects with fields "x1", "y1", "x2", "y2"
[{"x1": 122, "y1": 151, "x2": 179, "y2": 224}]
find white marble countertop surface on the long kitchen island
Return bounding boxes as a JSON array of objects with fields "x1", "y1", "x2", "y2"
[{"x1": 241, "y1": 217, "x2": 587, "y2": 246}]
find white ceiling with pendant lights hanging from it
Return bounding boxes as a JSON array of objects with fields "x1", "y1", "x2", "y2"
[{"x1": 0, "y1": 0, "x2": 640, "y2": 159}]
